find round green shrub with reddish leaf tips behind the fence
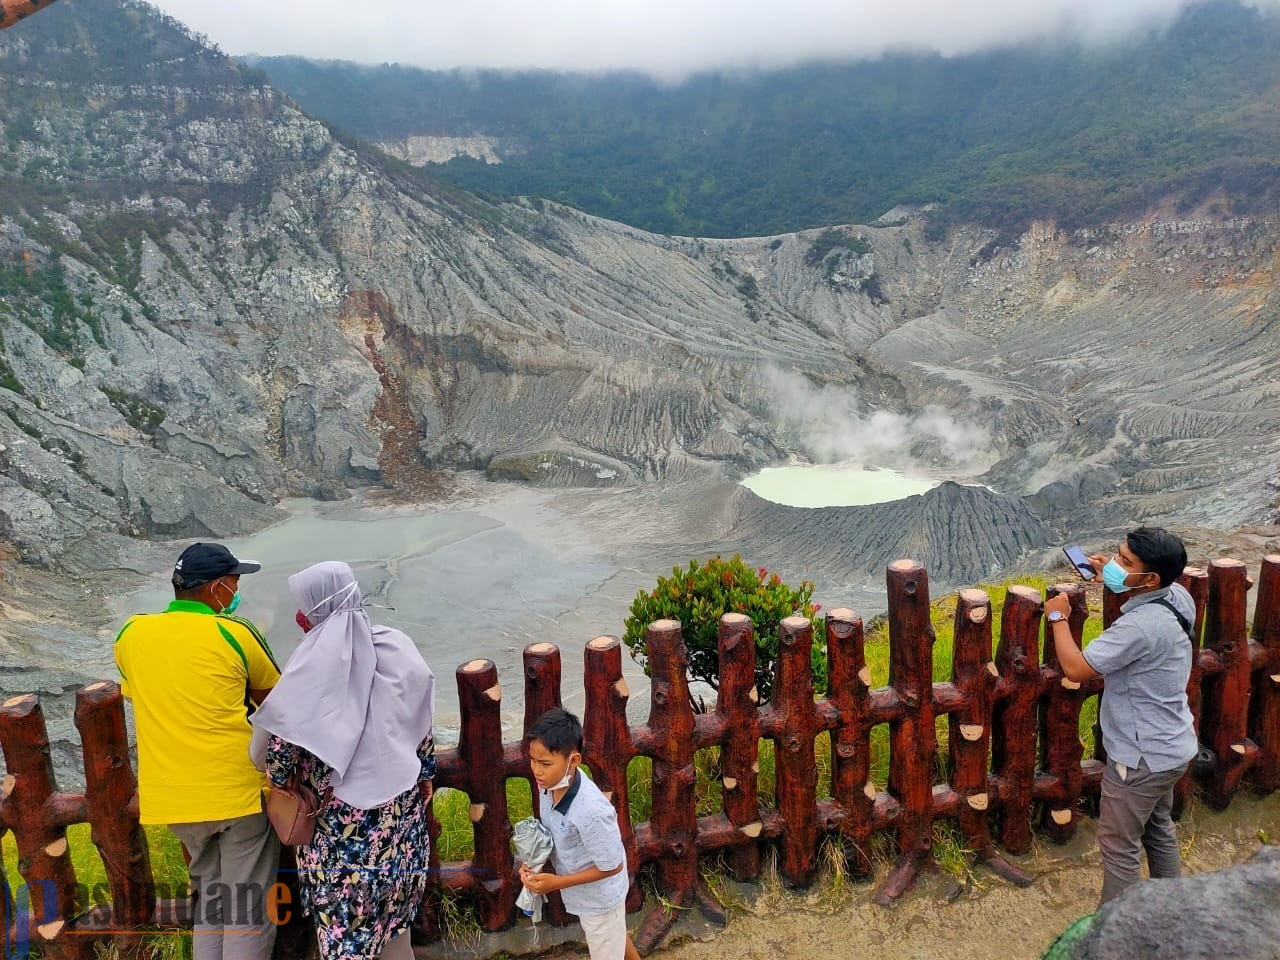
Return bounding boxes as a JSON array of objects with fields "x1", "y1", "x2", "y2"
[{"x1": 622, "y1": 554, "x2": 827, "y2": 703}]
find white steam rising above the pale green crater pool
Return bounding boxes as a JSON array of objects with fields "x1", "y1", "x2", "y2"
[{"x1": 767, "y1": 369, "x2": 992, "y2": 475}]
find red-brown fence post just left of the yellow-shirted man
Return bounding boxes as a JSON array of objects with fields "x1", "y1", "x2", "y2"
[{"x1": 76, "y1": 680, "x2": 156, "y2": 927}]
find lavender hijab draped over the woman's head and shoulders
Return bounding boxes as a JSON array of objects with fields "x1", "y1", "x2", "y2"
[{"x1": 250, "y1": 561, "x2": 435, "y2": 810}]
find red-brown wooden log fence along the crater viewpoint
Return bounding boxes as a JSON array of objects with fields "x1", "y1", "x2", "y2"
[{"x1": 0, "y1": 557, "x2": 1280, "y2": 957}]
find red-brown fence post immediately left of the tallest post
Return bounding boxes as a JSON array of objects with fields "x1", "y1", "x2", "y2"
[{"x1": 827, "y1": 608, "x2": 876, "y2": 879}]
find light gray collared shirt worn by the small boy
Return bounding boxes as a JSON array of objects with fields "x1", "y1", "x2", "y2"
[{"x1": 540, "y1": 771, "x2": 631, "y2": 916}]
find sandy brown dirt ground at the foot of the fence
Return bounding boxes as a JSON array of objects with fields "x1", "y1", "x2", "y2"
[{"x1": 524, "y1": 794, "x2": 1280, "y2": 960}]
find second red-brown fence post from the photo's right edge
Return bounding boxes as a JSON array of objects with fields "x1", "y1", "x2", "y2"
[{"x1": 1201, "y1": 558, "x2": 1257, "y2": 810}]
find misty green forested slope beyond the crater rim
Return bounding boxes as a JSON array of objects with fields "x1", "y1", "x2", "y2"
[{"x1": 257, "y1": 0, "x2": 1280, "y2": 236}]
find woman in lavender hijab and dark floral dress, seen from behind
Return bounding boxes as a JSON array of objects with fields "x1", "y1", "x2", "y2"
[{"x1": 250, "y1": 561, "x2": 435, "y2": 960}]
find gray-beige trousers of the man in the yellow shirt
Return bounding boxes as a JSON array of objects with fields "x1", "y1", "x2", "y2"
[{"x1": 169, "y1": 813, "x2": 280, "y2": 960}]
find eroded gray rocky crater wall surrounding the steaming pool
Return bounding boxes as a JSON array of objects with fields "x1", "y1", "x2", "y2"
[{"x1": 0, "y1": 0, "x2": 1280, "y2": 577}]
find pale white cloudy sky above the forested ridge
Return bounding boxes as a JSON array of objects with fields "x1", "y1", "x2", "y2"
[{"x1": 145, "y1": 0, "x2": 1280, "y2": 79}]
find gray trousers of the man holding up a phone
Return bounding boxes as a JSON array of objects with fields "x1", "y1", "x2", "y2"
[{"x1": 1098, "y1": 760, "x2": 1187, "y2": 905}]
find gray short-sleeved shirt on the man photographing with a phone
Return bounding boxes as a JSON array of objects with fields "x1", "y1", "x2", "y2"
[{"x1": 1084, "y1": 584, "x2": 1197, "y2": 773}]
